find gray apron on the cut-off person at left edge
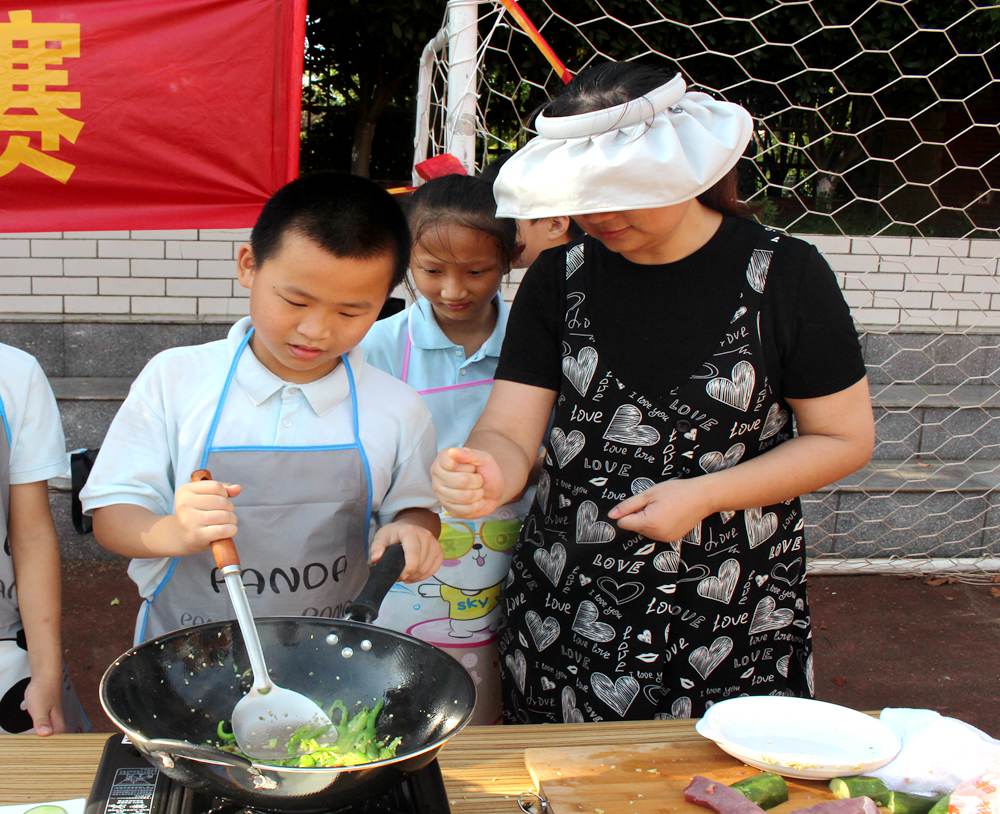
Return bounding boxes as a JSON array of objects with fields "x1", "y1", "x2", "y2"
[{"x1": 0, "y1": 399, "x2": 90, "y2": 734}]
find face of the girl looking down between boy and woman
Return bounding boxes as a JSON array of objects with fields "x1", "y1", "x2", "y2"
[{"x1": 410, "y1": 223, "x2": 503, "y2": 330}]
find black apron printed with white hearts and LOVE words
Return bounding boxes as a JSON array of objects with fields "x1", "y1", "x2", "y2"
[{"x1": 499, "y1": 230, "x2": 813, "y2": 723}]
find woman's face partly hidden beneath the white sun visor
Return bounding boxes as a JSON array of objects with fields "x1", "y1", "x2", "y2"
[{"x1": 573, "y1": 201, "x2": 693, "y2": 264}]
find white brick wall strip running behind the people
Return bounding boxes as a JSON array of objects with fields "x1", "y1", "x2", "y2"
[{"x1": 0, "y1": 229, "x2": 1000, "y2": 329}]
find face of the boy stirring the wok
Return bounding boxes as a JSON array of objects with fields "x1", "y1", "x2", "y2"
[{"x1": 237, "y1": 232, "x2": 393, "y2": 384}]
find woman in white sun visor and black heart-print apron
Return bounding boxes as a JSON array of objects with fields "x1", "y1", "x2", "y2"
[{"x1": 432, "y1": 63, "x2": 873, "y2": 722}]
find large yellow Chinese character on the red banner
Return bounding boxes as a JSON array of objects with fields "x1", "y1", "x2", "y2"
[{"x1": 0, "y1": 10, "x2": 83, "y2": 184}]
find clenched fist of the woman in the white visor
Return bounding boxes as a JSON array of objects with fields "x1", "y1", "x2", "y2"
[{"x1": 431, "y1": 447, "x2": 504, "y2": 518}]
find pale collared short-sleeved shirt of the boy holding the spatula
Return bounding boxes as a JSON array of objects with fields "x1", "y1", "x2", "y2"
[{"x1": 87, "y1": 317, "x2": 438, "y2": 524}]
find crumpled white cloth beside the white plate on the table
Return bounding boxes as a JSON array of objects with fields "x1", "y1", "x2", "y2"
[{"x1": 869, "y1": 707, "x2": 1000, "y2": 795}]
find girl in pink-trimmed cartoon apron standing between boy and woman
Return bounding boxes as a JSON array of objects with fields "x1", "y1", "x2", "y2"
[{"x1": 362, "y1": 175, "x2": 530, "y2": 723}]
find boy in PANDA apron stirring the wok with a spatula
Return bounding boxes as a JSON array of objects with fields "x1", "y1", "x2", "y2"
[{"x1": 81, "y1": 173, "x2": 441, "y2": 642}]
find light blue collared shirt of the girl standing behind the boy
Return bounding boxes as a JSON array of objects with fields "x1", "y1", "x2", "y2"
[{"x1": 361, "y1": 294, "x2": 510, "y2": 449}]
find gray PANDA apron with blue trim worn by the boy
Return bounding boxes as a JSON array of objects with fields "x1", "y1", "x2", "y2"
[{"x1": 136, "y1": 328, "x2": 372, "y2": 643}]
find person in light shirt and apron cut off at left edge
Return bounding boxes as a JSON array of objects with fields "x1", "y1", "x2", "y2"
[{"x1": 0, "y1": 344, "x2": 89, "y2": 735}]
